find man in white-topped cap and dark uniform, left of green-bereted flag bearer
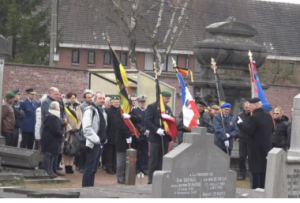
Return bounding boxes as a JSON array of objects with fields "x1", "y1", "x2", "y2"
[{"x1": 132, "y1": 95, "x2": 149, "y2": 175}]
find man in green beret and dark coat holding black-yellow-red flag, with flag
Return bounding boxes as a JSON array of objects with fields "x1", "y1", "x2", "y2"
[{"x1": 145, "y1": 63, "x2": 177, "y2": 184}]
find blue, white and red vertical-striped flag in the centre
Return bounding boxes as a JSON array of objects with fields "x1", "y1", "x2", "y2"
[{"x1": 177, "y1": 72, "x2": 200, "y2": 131}]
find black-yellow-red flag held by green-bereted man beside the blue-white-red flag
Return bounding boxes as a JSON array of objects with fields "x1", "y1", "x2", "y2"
[{"x1": 155, "y1": 78, "x2": 177, "y2": 142}]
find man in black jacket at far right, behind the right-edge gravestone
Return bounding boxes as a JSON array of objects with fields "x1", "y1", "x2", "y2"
[{"x1": 272, "y1": 106, "x2": 289, "y2": 150}]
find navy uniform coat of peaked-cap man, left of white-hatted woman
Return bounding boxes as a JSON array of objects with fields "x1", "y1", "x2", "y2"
[{"x1": 20, "y1": 98, "x2": 38, "y2": 133}]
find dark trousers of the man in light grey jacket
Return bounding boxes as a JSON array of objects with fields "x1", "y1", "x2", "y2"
[{"x1": 82, "y1": 145, "x2": 101, "y2": 187}]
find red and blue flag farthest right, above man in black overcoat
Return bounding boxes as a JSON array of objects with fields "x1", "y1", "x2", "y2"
[{"x1": 249, "y1": 61, "x2": 269, "y2": 104}]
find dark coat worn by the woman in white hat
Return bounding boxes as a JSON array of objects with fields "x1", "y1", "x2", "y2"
[{"x1": 41, "y1": 113, "x2": 64, "y2": 156}]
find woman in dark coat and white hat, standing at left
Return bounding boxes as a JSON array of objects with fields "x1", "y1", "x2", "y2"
[{"x1": 41, "y1": 101, "x2": 64, "y2": 178}]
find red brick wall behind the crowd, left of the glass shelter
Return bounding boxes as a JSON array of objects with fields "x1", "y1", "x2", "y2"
[{"x1": 3, "y1": 64, "x2": 88, "y2": 100}]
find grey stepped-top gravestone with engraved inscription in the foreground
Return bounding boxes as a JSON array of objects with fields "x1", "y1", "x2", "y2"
[{"x1": 152, "y1": 127, "x2": 237, "y2": 198}]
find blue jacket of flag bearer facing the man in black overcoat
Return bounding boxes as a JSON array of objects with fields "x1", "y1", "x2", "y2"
[{"x1": 213, "y1": 113, "x2": 239, "y2": 150}]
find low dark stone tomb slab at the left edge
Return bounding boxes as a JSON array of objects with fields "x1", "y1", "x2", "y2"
[{"x1": 0, "y1": 145, "x2": 39, "y2": 169}]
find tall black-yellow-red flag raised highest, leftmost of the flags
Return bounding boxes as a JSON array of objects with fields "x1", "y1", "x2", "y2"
[{"x1": 109, "y1": 45, "x2": 140, "y2": 137}]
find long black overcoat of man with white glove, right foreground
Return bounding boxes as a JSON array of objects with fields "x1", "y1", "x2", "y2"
[{"x1": 238, "y1": 108, "x2": 274, "y2": 173}]
